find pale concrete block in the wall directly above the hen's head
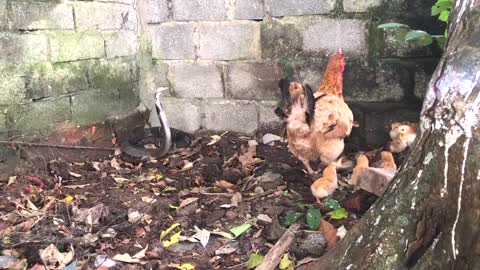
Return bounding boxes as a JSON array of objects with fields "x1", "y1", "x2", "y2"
[{"x1": 302, "y1": 18, "x2": 368, "y2": 55}]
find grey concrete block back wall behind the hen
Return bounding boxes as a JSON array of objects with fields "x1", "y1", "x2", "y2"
[{"x1": 140, "y1": 0, "x2": 438, "y2": 143}]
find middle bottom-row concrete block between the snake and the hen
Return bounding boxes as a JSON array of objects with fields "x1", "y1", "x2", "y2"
[{"x1": 203, "y1": 99, "x2": 258, "y2": 134}]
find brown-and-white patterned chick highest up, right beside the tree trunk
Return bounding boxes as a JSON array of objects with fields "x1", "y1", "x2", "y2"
[{"x1": 389, "y1": 122, "x2": 417, "y2": 153}]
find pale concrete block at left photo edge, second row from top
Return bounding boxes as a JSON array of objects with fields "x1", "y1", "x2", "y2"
[{"x1": 0, "y1": 33, "x2": 49, "y2": 64}]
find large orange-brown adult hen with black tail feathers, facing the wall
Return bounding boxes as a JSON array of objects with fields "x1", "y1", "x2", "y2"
[{"x1": 277, "y1": 50, "x2": 353, "y2": 174}]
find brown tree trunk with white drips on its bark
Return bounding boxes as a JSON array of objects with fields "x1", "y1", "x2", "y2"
[{"x1": 298, "y1": 0, "x2": 480, "y2": 270}]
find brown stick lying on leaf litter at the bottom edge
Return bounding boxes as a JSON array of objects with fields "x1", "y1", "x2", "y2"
[{"x1": 255, "y1": 223, "x2": 300, "y2": 270}]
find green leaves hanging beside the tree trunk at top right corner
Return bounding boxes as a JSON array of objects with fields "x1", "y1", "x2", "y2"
[{"x1": 378, "y1": 0, "x2": 453, "y2": 48}]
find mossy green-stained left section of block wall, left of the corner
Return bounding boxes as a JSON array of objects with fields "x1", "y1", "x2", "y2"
[{"x1": 0, "y1": 0, "x2": 140, "y2": 137}]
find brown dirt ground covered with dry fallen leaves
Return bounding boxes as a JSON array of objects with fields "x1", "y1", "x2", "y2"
[{"x1": 0, "y1": 134, "x2": 390, "y2": 269}]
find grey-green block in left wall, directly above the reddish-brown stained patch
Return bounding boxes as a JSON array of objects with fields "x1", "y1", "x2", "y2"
[{"x1": 71, "y1": 89, "x2": 122, "y2": 125}]
